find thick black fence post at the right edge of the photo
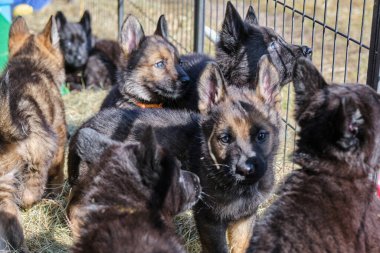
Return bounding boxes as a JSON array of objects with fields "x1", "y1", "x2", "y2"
[{"x1": 367, "y1": 0, "x2": 380, "y2": 92}]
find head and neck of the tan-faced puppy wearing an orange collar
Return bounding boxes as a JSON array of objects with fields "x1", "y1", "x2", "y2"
[{"x1": 102, "y1": 15, "x2": 189, "y2": 109}]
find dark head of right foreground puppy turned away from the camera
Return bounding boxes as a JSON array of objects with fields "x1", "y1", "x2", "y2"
[{"x1": 293, "y1": 58, "x2": 380, "y2": 172}]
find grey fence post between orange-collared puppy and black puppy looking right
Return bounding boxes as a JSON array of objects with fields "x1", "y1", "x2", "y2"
[{"x1": 194, "y1": 0, "x2": 205, "y2": 53}]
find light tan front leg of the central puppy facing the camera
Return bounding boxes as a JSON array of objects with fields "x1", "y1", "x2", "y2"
[{"x1": 227, "y1": 215, "x2": 256, "y2": 253}]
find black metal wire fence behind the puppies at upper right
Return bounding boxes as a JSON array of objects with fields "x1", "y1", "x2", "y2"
[{"x1": 120, "y1": 0, "x2": 380, "y2": 177}]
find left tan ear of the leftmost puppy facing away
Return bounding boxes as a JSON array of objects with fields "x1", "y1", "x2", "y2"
[{"x1": 9, "y1": 16, "x2": 30, "y2": 55}]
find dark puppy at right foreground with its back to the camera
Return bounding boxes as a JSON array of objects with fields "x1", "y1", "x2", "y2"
[{"x1": 248, "y1": 59, "x2": 380, "y2": 253}]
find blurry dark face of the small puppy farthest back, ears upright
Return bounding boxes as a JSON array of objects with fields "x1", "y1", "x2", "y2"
[{"x1": 55, "y1": 11, "x2": 91, "y2": 68}]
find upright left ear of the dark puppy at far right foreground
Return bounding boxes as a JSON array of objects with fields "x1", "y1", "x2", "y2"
[{"x1": 293, "y1": 57, "x2": 327, "y2": 107}]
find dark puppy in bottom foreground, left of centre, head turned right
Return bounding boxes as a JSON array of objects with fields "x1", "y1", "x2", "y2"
[{"x1": 73, "y1": 127, "x2": 201, "y2": 253}]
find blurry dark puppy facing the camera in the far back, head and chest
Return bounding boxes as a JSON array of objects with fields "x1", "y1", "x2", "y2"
[{"x1": 55, "y1": 10, "x2": 95, "y2": 89}]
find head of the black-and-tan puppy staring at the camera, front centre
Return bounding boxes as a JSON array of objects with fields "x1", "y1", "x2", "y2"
[{"x1": 199, "y1": 56, "x2": 280, "y2": 191}]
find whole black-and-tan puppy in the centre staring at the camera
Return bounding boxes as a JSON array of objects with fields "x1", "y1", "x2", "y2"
[{"x1": 68, "y1": 56, "x2": 281, "y2": 252}]
